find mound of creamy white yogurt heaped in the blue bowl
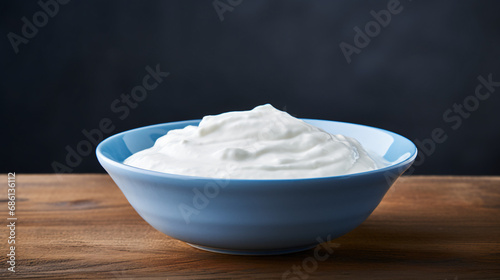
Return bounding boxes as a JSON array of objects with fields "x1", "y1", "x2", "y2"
[{"x1": 124, "y1": 104, "x2": 384, "y2": 179}]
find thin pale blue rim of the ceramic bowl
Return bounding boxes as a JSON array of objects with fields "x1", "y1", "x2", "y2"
[{"x1": 95, "y1": 118, "x2": 418, "y2": 182}]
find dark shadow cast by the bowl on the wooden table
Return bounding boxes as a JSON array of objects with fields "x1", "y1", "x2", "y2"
[{"x1": 183, "y1": 222, "x2": 459, "y2": 274}]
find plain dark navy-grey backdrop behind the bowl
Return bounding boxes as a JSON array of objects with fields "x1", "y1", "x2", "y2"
[{"x1": 0, "y1": 0, "x2": 500, "y2": 175}]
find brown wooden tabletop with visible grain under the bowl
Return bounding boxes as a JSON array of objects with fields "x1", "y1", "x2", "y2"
[{"x1": 0, "y1": 174, "x2": 500, "y2": 280}]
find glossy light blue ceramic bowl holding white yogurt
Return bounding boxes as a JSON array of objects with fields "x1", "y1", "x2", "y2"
[{"x1": 96, "y1": 119, "x2": 417, "y2": 254}]
